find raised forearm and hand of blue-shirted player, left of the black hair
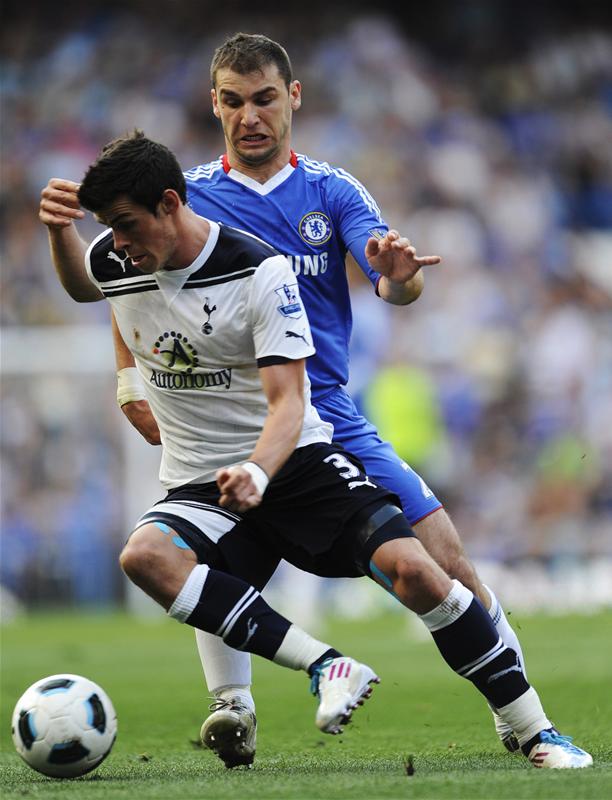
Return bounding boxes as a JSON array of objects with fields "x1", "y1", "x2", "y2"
[{"x1": 38, "y1": 178, "x2": 102, "y2": 303}]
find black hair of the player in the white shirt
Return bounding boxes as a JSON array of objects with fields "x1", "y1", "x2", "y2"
[{"x1": 79, "y1": 130, "x2": 187, "y2": 214}]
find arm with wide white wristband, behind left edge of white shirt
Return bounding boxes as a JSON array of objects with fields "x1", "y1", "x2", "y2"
[{"x1": 111, "y1": 311, "x2": 161, "y2": 444}]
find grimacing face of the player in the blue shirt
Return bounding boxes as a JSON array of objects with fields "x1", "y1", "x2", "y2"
[{"x1": 212, "y1": 64, "x2": 301, "y2": 169}]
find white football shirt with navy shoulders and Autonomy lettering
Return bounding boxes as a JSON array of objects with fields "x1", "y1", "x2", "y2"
[{"x1": 85, "y1": 220, "x2": 333, "y2": 489}]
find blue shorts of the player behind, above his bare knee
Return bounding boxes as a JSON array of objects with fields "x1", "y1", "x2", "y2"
[{"x1": 313, "y1": 387, "x2": 442, "y2": 525}]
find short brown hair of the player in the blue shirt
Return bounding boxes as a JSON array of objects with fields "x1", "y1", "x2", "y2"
[{"x1": 210, "y1": 33, "x2": 293, "y2": 88}]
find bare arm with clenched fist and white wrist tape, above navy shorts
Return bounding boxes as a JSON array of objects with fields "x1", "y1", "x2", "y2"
[{"x1": 217, "y1": 359, "x2": 304, "y2": 512}]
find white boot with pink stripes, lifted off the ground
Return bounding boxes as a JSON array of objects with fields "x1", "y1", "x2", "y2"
[{"x1": 310, "y1": 656, "x2": 380, "y2": 734}]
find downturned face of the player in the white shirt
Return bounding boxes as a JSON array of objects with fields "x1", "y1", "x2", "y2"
[{"x1": 96, "y1": 197, "x2": 177, "y2": 274}]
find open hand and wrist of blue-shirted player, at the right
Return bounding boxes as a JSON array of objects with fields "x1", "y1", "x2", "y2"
[{"x1": 365, "y1": 229, "x2": 442, "y2": 305}]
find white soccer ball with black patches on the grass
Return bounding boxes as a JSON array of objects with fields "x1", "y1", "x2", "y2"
[{"x1": 12, "y1": 675, "x2": 117, "y2": 778}]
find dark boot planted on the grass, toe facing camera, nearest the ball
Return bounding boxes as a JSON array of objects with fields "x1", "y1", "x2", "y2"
[{"x1": 200, "y1": 697, "x2": 257, "y2": 769}]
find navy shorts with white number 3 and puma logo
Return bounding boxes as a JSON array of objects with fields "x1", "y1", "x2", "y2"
[{"x1": 137, "y1": 443, "x2": 413, "y2": 589}]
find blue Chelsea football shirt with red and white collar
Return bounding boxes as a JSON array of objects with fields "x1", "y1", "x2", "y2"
[{"x1": 185, "y1": 153, "x2": 388, "y2": 399}]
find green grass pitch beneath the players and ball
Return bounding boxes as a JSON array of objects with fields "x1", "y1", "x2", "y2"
[{"x1": 0, "y1": 612, "x2": 612, "y2": 800}]
